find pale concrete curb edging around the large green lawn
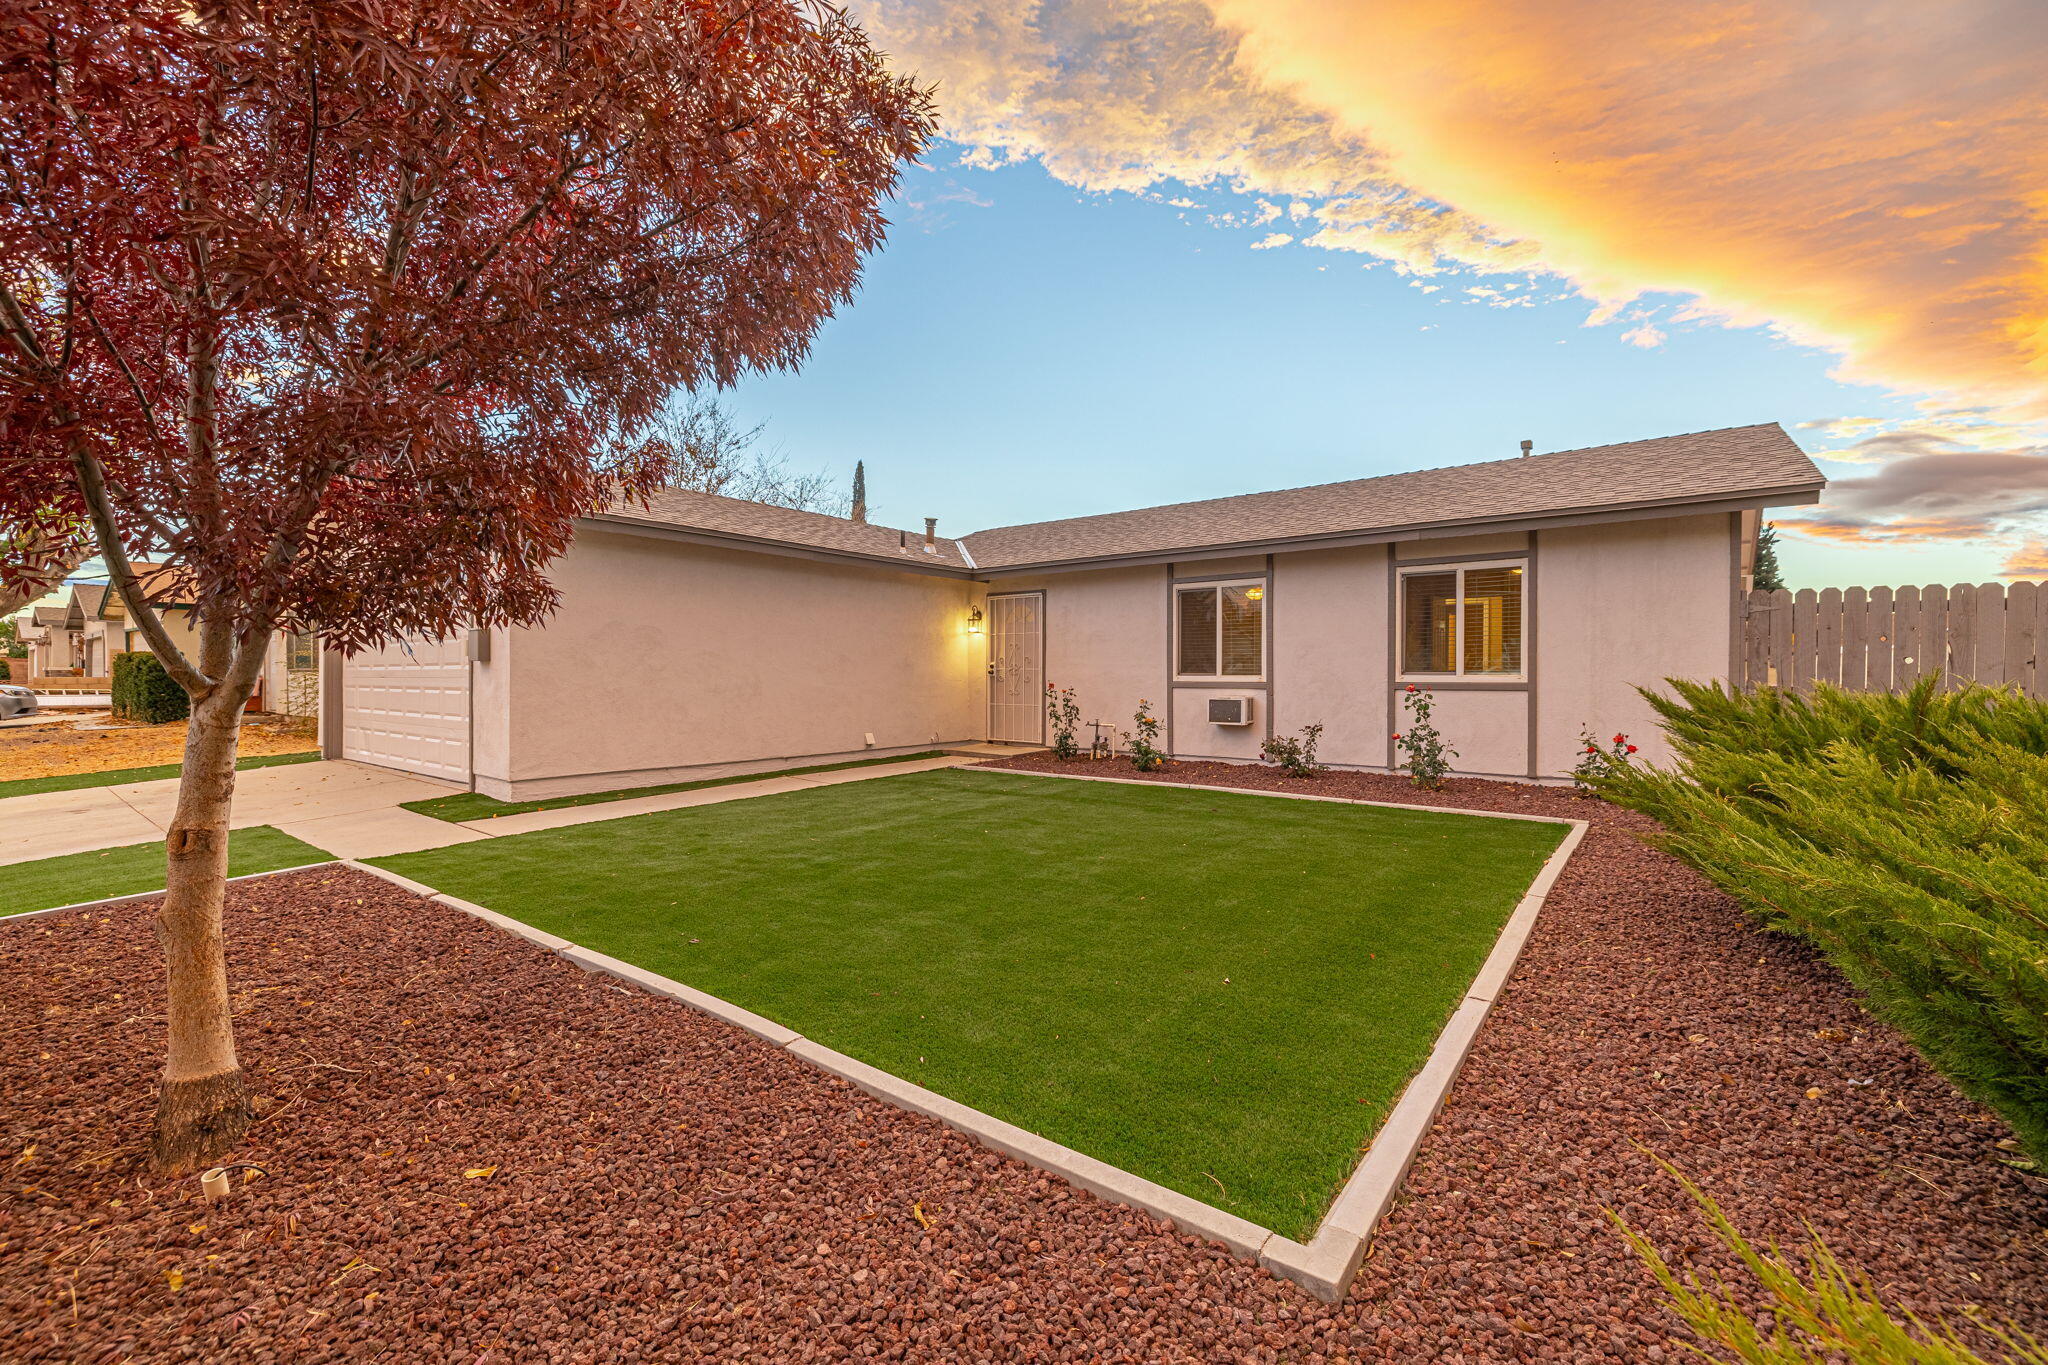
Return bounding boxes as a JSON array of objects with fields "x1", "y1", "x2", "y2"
[{"x1": 335, "y1": 769, "x2": 1587, "y2": 1304}]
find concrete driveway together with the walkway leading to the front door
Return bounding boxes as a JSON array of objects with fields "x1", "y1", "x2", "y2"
[{"x1": 0, "y1": 755, "x2": 977, "y2": 866}]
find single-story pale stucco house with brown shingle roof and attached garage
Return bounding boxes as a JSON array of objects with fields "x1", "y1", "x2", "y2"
[{"x1": 322, "y1": 424, "x2": 1823, "y2": 800}]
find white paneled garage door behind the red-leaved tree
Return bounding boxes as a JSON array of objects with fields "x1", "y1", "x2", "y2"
[{"x1": 342, "y1": 634, "x2": 469, "y2": 782}]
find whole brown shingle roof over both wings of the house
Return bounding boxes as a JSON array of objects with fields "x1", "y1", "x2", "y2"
[{"x1": 598, "y1": 422, "x2": 1825, "y2": 571}]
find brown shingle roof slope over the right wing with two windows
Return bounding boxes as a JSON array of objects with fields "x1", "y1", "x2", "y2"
[{"x1": 965, "y1": 422, "x2": 1823, "y2": 569}]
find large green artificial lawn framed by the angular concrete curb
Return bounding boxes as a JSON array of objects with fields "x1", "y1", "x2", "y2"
[{"x1": 377, "y1": 769, "x2": 1565, "y2": 1240}]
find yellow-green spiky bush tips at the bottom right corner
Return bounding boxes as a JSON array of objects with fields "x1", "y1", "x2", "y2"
[{"x1": 1608, "y1": 1162, "x2": 2048, "y2": 1365}]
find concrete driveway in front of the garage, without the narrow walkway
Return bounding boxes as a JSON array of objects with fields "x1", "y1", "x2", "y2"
[{"x1": 0, "y1": 761, "x2": 483, "y2": 866}]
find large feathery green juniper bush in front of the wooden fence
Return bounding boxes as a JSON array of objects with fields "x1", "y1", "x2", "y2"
[{"x1": 1595, "y1": 679, "x2": 2048, "y2": 1160}]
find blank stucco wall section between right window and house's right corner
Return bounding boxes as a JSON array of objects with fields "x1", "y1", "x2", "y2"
[{"x1": 1536, "y1": 514, "x2": 1739, "y2": 774}]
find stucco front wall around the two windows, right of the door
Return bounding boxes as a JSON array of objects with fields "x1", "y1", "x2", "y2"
[{"x1": 993, "y1": 514, "x2": 1735, "y2": 778}]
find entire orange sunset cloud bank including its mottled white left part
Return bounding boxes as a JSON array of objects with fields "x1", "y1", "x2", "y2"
[{"x1": 856, "y1": 0, "x2": 2048, "y2": 420}]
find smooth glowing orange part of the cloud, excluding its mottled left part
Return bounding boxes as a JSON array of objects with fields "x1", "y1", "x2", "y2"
[{"x1": 1210, "y1": 0, "x2": 2048, "y2": 415}]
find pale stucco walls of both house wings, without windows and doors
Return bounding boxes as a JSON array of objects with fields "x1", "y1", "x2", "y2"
[{"x1": 403, "y1": 514, "x2": 1737, "y2": 798}]
